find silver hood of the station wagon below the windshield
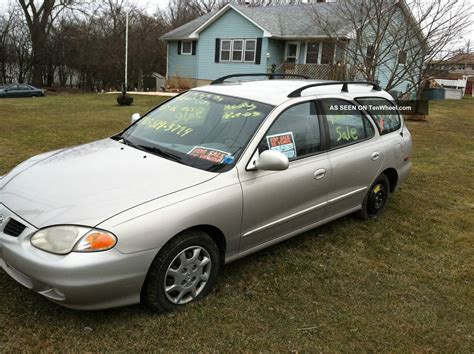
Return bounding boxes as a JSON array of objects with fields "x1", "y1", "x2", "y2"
[{"x1": 0, "y1": 139, "x2": 217, "y2": 228}]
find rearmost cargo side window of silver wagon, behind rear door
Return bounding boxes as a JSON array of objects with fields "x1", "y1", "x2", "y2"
[{"x1": 356, "y1": 97, "x2": 402, "y2": 135}]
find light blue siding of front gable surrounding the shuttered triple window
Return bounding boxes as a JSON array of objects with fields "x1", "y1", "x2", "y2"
[{"x1": 197, "y1": 9, "x2": 268, "y2": 80}]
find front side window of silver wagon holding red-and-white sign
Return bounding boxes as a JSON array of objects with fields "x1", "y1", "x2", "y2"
[{"x1": 259, "y1": 102, "x2": 321, "y2": 161}]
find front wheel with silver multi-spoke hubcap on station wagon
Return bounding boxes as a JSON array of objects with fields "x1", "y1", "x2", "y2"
[{"x1": 141, "y1": 230, "x2": 220, "y2": 313}]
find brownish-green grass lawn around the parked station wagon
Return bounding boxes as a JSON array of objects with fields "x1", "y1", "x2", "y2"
[{"x1": 0, "y1": 95, "x2": 474, "y2": 352}]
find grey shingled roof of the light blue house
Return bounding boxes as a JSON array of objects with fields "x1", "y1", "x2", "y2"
[{"x1": 161, "y1": 2, "x2": 351, "y2": 40}]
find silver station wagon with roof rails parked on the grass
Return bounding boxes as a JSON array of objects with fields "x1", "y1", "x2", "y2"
[{"x1": 0, "y1": 75, "x2": 412, "y2": 312}]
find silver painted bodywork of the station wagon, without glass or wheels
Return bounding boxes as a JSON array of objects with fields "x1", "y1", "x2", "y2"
[{"x1": 0, "y1": 80, "x2": 412, "y2": 309}]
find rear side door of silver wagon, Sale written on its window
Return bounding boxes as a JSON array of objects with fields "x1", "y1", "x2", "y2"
[{"x1": 317, "y1": 98, "x2": 385, "y2": 215}]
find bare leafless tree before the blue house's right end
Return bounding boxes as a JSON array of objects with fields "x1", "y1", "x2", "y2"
[{"x1": 312, "y1": 0, "x2": 471, "y2": 97}]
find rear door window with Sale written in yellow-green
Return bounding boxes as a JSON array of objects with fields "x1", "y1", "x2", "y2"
[{"x1": 321, "y1": 98, "x2": 375, "y2": 148}]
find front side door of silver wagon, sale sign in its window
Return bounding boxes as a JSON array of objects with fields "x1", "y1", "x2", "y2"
[{"x1": 239, "y1": 102, "x2": 331, "y2": 252}]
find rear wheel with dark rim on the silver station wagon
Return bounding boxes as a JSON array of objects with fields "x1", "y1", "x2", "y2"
[{"x1": 357, "y1": 174, "x2": 390, "y2": 220}]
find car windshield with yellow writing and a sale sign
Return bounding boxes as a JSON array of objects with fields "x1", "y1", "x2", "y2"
[{"x1": 117, "y1": 91, "x2": 273, "y2": 172}]
